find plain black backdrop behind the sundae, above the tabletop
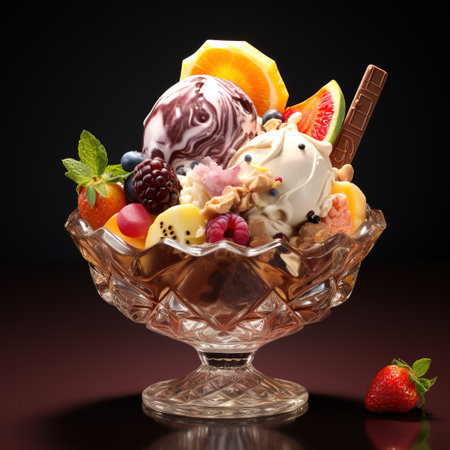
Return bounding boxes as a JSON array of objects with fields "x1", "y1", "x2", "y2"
[{"x1": 1, "y1": 2, "x2": 448, "y2": 261}]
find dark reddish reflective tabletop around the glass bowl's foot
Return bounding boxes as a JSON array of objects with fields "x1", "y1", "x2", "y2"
[{"x1": 0, "y1": 261, "x2": 450, "y2": 450}]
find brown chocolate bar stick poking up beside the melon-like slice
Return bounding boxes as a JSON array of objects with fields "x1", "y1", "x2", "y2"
[{"x1": 330, "y1": 64, "x2": 387, "y2": 169}]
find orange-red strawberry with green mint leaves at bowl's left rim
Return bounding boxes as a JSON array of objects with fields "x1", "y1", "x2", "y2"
[{"x1": 62, "y1": 130, "x2": 131, "y2": 230}]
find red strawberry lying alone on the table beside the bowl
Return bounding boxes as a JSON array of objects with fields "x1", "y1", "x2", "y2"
[{"x1": 364, "y1": 358, "x2": 436, "y2": 413}]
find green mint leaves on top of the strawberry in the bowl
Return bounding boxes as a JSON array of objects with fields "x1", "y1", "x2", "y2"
[{"x1": 62, "y1": 130, "x2": 131, "y2": 206}]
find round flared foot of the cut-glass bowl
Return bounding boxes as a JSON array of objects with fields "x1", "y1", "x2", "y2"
[{"x1": 142, "y1": 364, "x2": 308, "y2": 419}]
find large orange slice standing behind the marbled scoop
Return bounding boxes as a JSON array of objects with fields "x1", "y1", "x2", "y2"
[{"x1": 180, "y1": 39, "x2": 289, "y2": 117}]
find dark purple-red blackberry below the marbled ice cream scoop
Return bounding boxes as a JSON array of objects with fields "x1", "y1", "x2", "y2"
[{"x1": 133, "y1": 157, "x2": 181, "y2": 215}]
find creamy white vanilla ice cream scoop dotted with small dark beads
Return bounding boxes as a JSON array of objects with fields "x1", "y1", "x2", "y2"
[{"x1": 228, "y1": 124, "x2": 335, "y2": 235}]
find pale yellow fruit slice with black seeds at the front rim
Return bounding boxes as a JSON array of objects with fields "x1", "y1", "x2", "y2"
[{"x1": 145, "y1": 204, "x2": 206, "y2": 248}]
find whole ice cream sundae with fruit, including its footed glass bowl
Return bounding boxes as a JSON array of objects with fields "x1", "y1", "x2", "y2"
[{"x1": 63, "y1": 40, "x2": 386, "y2": 418}]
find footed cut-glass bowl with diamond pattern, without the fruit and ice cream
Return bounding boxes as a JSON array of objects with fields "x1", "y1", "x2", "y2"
[{"x1": 66, "y1": 208, "x2": 386, "y2": 418}]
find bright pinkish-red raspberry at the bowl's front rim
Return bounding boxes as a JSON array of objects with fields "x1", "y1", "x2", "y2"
[{"x1": 206, "y1": 212, "x2": 249, "y2": 245}]
